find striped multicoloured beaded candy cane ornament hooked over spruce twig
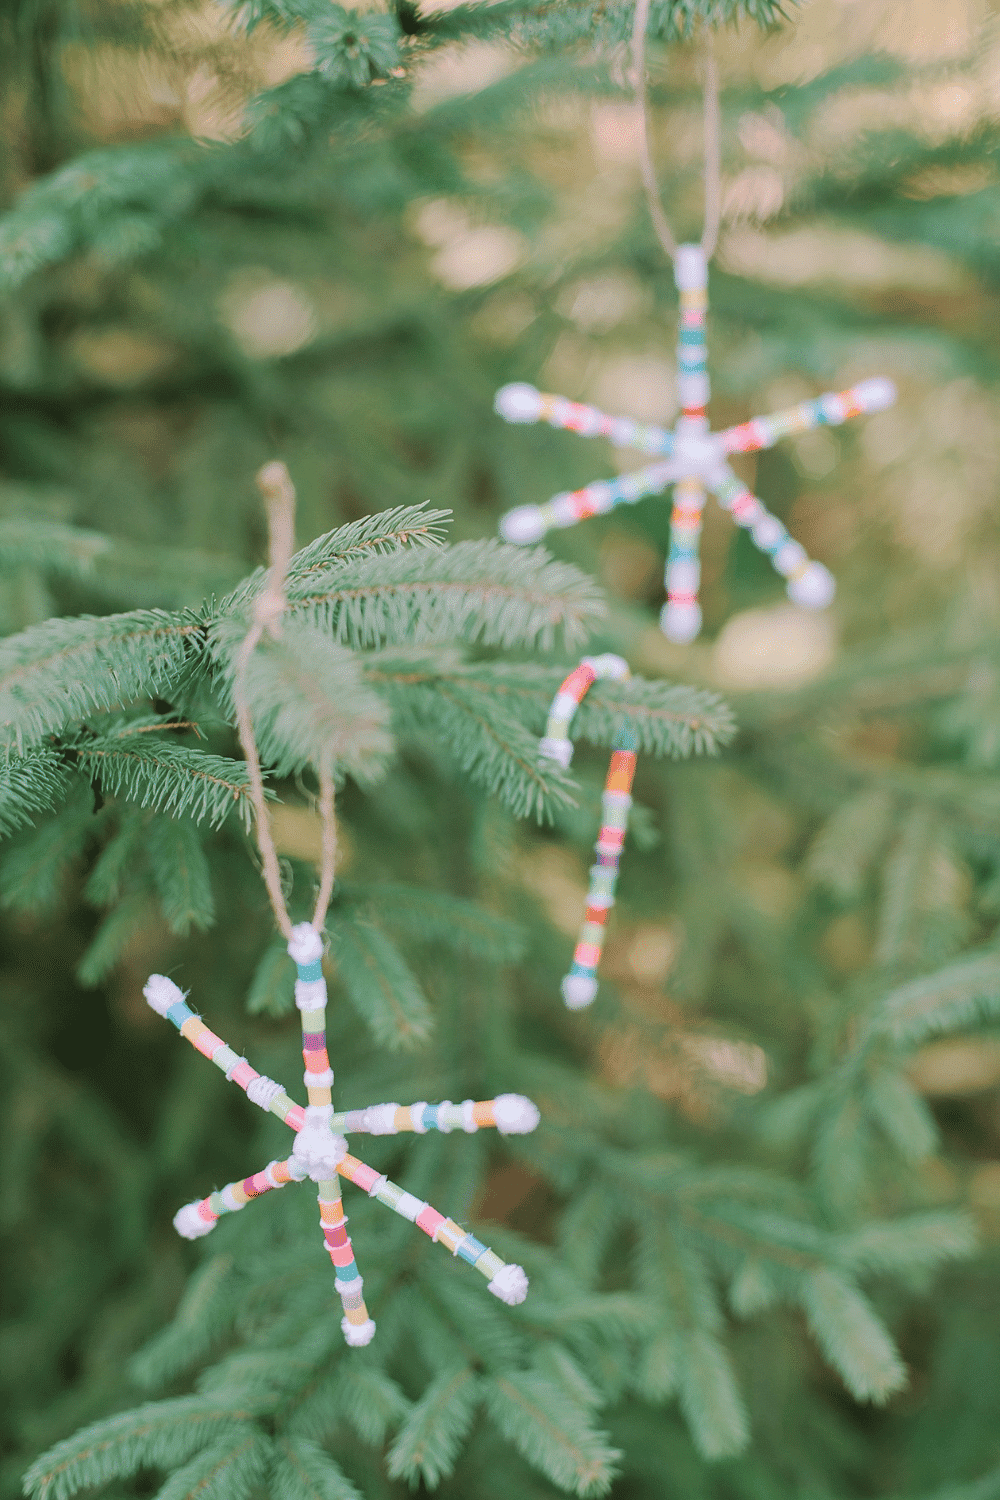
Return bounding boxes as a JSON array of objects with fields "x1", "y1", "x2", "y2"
[{"x1": 538, "y1": 654, "x2": 639, "y2": 1011}]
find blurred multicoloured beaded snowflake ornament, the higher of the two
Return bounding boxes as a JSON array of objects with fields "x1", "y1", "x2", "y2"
[{"x1": 496, "y1": 245, "x2": 897, "y2": 642}]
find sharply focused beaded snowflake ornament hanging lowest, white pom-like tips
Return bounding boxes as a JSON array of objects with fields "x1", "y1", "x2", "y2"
[{"x1": 142, "y1": 923, "x2": 538, "y2": 1346}]
